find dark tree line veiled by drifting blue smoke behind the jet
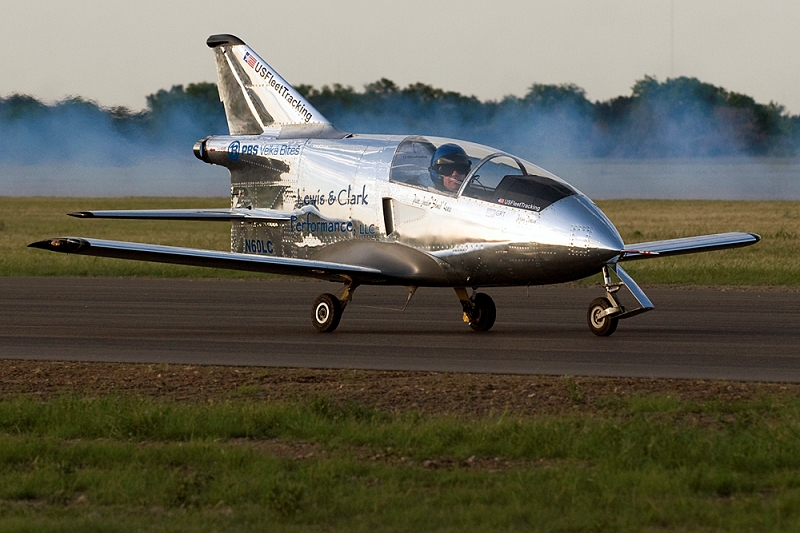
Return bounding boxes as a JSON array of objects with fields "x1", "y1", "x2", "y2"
[{"x1": 0, "y1": 76, "x2": 800, "y2": 161}]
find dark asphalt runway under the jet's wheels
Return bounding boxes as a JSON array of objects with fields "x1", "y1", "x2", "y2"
[{"x1": 0, "y1": 278, "x2": 800, "y2": 382}]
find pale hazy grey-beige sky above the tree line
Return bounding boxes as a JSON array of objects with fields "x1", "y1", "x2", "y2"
[{"x1": 6, "y1": 0, "x2": 800, "y2": 114}]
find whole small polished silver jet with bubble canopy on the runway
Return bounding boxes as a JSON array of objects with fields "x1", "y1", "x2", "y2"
[{"x1": 30, "y1": 35, "x2": 760, "y2": 336}]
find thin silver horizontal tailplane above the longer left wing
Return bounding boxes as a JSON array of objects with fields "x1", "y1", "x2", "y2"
[{"x1": 69, "y1": 208, "x2": 297, "y2": 222}]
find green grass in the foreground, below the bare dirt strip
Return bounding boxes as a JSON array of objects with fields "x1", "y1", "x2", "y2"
[{"x1": 0, "y1": 394, "x2": 800, "y2": 532}]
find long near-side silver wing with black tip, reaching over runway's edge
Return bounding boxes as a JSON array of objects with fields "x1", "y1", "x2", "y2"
[{"x1": 28, "y1": 237, "x2": 384, "y2": 281}]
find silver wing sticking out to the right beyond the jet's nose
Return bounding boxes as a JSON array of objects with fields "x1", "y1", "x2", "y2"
[{"x1": 619, "y1": 232, "x2": 761, "y2": 261}]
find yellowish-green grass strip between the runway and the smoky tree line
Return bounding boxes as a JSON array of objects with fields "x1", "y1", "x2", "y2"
[{"x1": 0, "y1": 197, "x2": 800, "y2": 286}]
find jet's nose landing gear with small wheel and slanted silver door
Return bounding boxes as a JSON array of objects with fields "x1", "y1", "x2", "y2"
[{"x1": 586, "y1": 265, "x2": 653, "y2": 337}]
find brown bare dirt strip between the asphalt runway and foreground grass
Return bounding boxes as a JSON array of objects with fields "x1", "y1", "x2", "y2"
[{"x1": 0, "y1": 360, "x2": 800, "y2": 416}]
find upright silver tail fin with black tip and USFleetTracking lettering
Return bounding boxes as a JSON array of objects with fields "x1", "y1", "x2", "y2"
[{"x1": 206, "y1": 34, "x2": 338, "y2": 135}]
